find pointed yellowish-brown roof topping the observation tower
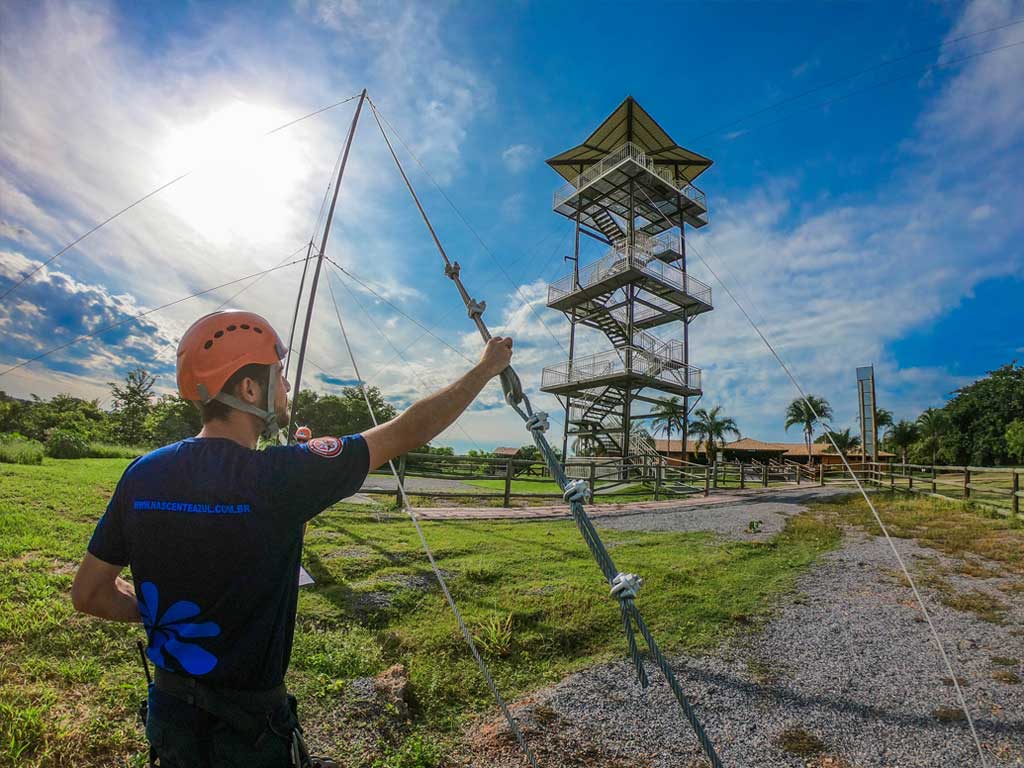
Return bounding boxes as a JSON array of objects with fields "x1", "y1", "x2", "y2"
[{"x1": 548, "y1": 96, "x2": 712, "y2": 181}]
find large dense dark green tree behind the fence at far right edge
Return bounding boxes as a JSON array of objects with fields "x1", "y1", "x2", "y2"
[{"x1": 942, "y1": 362, "x2": 1024, "y2": 466}]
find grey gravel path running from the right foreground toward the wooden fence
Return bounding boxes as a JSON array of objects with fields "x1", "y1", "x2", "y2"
[{"x1": 465, "y1": 492, "x2": 1024, "y2": 768}]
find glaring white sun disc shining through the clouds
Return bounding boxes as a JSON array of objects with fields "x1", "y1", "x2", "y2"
[{"x1": 161, "y1": 101, "x2": 306, "y2": 245}]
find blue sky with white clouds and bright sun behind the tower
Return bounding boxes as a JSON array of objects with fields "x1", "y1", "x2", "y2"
[{"x1": 0, "y1": 0, "x2": 1024, "y2": 449}]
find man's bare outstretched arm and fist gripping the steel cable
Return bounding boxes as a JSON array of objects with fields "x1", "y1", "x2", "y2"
[{"x1": 362, "y1": 336, "x2": 512, "y2": 470}]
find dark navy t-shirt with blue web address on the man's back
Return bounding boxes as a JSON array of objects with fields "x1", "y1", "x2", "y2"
[{"x1": 89, "y1": 435, "x2": 370, "y2": 690}]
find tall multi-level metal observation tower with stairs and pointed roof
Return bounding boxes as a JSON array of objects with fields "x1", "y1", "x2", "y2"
[{"x1": 541, "y1": 96, "x2": 712, "y2": 479}]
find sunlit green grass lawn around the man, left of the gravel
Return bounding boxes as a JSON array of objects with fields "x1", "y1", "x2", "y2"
[{"x1": 0, "y1": 459, "x2": 840, "y2": 768}]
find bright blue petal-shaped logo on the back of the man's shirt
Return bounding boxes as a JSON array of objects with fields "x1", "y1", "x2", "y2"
[{"x1": 138, "y1": 582, "x2": 220, "y2": 675}]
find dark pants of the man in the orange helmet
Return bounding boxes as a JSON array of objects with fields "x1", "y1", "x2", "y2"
[{"x1": 145, "y1": 686, "x2": 295, "y2": 768}]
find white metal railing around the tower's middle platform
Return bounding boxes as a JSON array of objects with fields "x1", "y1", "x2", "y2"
[{"x1": 548, "y1": 232, "x2": 712, "y2": 311}]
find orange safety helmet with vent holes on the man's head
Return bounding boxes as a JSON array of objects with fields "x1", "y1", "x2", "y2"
[{"x1": 177, "y1": 309, "x2": 287, "y2": 410}]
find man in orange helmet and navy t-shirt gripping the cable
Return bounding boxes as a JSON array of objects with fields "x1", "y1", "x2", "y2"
[{"x1": 72, "y1": 311, "x2": 512, "y2": 768}]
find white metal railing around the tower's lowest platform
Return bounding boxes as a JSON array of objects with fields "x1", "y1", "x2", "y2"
[{"x1": 541, "y1": 350, "x2": 700, "y2": 397}]
